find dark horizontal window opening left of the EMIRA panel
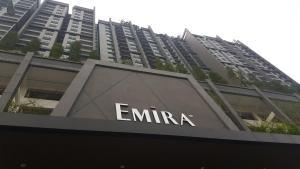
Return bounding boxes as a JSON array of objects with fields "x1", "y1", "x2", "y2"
[{"x1": 25, "y1": 89, "x2": 63, "y2": 100}]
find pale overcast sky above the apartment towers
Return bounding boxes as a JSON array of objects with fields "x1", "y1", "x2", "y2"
[{"x1": 52, "y1": 0, "x2": 300, "y2": 82}]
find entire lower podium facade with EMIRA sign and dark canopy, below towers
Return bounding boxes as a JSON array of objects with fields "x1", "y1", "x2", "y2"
[{"x1": 0, "y1": 52, "x2": 300, "y2": 169}]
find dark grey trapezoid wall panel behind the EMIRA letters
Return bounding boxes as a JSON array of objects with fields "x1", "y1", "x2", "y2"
[{"x1": 69, "y1": 66, "x2": 231, "y2": 129}]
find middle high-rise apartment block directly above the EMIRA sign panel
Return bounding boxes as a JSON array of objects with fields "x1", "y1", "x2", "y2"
[{"x1": 98, "y1": 20, "x2": 186, "y2": 69}]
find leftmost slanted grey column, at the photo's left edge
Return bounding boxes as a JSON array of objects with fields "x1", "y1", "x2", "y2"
[{"x1": 0, "y1": 52, "x2": 33, "y2": 112}]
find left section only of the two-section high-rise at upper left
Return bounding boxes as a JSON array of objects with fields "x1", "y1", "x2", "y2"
[{"x1": 18, "y1": 0, "x2": 69, "y2": 57}]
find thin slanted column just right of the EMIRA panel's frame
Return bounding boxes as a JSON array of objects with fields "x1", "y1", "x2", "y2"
[{"x1": 206, "y1": 79, "x2": 250, "y2": 131}]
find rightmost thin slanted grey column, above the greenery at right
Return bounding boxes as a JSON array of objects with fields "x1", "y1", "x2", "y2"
[{"x1": 252, "y1": 85, "x2": 294, "y2": 124}]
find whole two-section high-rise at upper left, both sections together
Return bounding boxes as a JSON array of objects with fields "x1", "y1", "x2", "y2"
[{"x1": 18, "y1": 0, "x2": 96, "y2": 58}]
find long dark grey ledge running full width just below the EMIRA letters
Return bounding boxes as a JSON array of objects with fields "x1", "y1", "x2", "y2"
[{"x1": 0, "y1": 113, "x2": 300, "y2": 145}]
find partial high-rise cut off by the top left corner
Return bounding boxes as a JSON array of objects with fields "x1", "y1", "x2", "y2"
[{"x1": 0, "y1": 0, "x2": 39, "y2": 40}]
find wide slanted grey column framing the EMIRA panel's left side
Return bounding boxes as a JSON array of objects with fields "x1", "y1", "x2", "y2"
[{"x1": 51, "y1": 59, "x2": 96, "y2": 117}]
